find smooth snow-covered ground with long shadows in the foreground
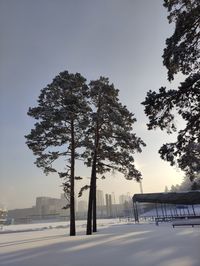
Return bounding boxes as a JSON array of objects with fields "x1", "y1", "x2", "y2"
[{"x1": 0, "y1": 220, "x2": 200, "y2": 266}]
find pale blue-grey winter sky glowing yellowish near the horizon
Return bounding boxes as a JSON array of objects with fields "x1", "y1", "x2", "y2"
[{"x1": 0, "y1": 0, "x2": 183, "y2": 208}]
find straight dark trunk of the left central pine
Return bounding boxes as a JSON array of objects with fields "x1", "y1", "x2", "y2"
[{"x1": 70, "y1": 120, "x2": 76, "y2": 236}]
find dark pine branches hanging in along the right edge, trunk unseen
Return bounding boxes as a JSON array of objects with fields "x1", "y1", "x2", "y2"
[{"x1": 142, "y1": 0, "x2": 200, "y2": 180}]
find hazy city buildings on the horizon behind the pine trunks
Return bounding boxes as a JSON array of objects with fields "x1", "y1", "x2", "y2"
[{"x1": 6, "y1": 190, "x2": 133, "y2": 224}]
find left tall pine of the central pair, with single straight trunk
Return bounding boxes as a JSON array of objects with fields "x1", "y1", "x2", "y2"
[{"x1": 25, "y1": 71, "x2": 90, "y2": 236}]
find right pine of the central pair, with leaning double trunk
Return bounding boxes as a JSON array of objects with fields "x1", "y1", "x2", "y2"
[{"x1": 84, "y1": 77, "x2": 145, "y2": 234}]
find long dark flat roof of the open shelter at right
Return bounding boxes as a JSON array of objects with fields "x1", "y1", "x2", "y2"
[{"x1": 132, "y1": 190, "x2": 200, "y2": 205}]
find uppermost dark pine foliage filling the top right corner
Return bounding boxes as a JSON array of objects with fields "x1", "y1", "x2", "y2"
[{"x1": 163, "y1": 0, "x2": 200, "y2": 80}]
